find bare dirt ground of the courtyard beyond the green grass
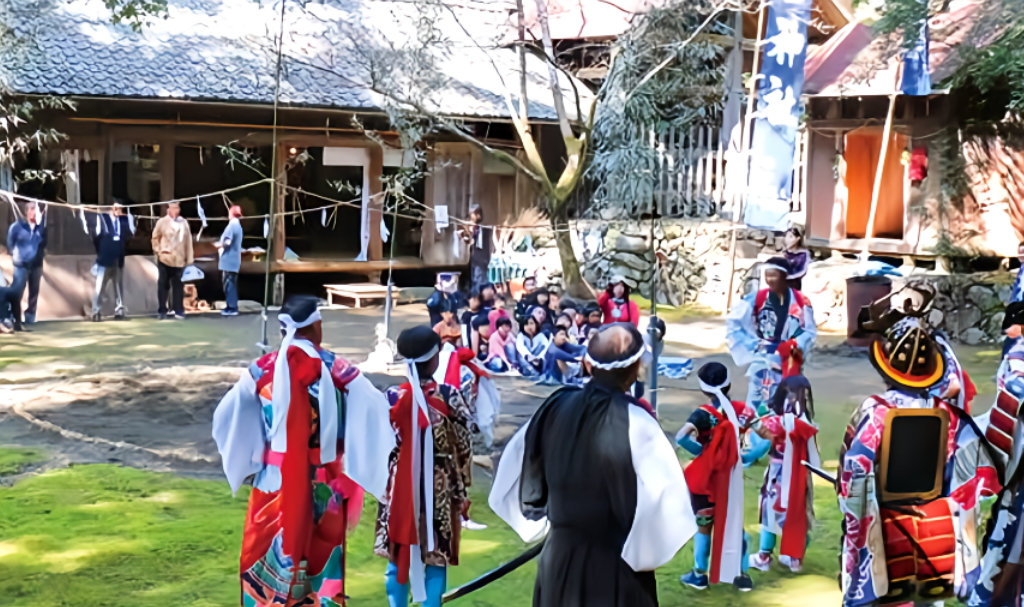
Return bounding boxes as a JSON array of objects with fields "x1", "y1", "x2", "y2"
[{"x1": 0, "y1": 305, "x2": 997, "y2": 481}]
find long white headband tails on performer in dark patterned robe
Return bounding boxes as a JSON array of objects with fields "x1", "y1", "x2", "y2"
[{"x1": 406, "y1": 346, "x2": 438, "y2": 603}]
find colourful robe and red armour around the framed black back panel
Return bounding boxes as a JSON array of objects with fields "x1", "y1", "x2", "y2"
[{"x1": 838, "y1": 390, "x2": 999, "y2": 607}]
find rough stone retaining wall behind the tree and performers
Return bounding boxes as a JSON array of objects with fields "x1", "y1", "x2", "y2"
[{"x1": 499, "y1": 220, "x2": 1015, "y2": 345}]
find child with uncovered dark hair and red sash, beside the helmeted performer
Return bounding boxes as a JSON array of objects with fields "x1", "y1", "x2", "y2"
[{"x1": 751, "y1": 375, "x2": 821, "y2": 573}]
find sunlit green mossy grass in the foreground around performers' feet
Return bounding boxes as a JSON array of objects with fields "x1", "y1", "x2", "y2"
[{"x1": 0, "y1": 417, "x2": 839, "y2": 607}]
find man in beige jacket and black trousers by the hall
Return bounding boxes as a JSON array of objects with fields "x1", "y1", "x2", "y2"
[{"x1": 153, "y1": 203, "x2": 193, "y2": 320}]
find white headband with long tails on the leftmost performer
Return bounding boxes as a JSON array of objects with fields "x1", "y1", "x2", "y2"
[{"x1": 268, "y1": 310, "x2": 338, "y2": 464}]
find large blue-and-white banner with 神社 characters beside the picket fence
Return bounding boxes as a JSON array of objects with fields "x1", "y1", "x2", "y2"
[{"x1": 743, "y1": 0, "x2": 811, "y2": 231}]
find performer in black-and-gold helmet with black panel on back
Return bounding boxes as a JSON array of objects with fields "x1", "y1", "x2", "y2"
[{"x1": 837, "y1": 293, "x2": 1004, "y2": 607}]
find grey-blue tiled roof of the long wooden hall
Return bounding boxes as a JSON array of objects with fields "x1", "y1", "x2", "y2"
[{"x1": 0, "y1": 0, "x2": 589, "y2": 120}]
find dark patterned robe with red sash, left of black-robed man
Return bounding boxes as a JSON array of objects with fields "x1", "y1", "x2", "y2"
[{"x1": 374, "y1": 381, "x2": 475, "y2": 584}]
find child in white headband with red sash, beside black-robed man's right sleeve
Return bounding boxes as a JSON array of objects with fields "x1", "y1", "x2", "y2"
[{"x1": 676, "y1": 362, "x2": 757, "y2": 592}]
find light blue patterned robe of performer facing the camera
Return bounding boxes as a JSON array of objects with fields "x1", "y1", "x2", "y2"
[{"x1": 726, "y1": 289, "x2": 818, "y2": 415}]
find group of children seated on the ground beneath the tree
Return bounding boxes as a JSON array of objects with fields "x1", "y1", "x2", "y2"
[{"x1": 427, "y1": 277, "x2": 639, "y2": 385}]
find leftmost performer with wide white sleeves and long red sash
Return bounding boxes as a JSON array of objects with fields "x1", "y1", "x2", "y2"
[{"x1": 213, "y1": 297, "x2": 394, "y2": 607}]
